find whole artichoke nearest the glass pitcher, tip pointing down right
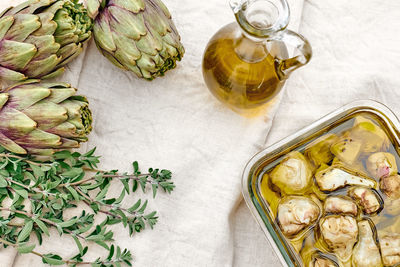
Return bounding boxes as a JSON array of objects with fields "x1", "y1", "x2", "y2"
[{"x1": 87, "y1": 0, "x2": 185, "y2": 80}]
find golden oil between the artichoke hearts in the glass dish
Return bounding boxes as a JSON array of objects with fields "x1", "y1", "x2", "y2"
[{"x1": 259, "y1": 113, "x2": 400, "y2": 266}]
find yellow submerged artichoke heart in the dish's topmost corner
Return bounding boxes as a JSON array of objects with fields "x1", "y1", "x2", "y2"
[{"x1": 351, "y1": 116, "x2": 390, "y2": 153}]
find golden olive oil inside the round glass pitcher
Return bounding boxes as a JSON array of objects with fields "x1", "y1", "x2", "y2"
[{"x1": 203, "y1": 23, "x2": 284, "y2": 113}]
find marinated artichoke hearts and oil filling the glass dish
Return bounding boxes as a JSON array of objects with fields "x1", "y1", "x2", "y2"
[{"x1": 259, "y1": 113, "x2": 400, "y2": 267}]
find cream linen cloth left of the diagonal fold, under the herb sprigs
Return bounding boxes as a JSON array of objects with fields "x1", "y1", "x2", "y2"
[{"x1": 0, "y1": 0, "x2": 302, "y2": 266}]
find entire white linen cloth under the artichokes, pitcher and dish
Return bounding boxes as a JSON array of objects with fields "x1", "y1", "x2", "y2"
[{"x1": 0, "y1": 0, "x2": 400, "y2": 266}]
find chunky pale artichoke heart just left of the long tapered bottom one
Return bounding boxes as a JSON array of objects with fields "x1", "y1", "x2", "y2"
[{"x1": 319, "y1": 215, "x2": 358, "y2": 262}]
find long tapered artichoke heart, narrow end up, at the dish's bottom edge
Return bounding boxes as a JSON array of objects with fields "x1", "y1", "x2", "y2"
[{"x1": 352, "y1": 220, "x2": 383, "y2": 267}]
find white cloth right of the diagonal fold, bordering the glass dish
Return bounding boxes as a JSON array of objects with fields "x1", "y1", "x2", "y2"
[{"x1": 232, "y1": 0, "x2": 400, "y2": 266}]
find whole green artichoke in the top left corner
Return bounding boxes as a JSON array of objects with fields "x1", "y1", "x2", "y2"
[{"x1": 0, "y1": 0, "x2": 93, "y2": 84}]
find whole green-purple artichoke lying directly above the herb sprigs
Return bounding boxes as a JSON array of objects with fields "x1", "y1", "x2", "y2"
[{"x1": 0, "y1": 80, "x2": 92, "y2": 156}]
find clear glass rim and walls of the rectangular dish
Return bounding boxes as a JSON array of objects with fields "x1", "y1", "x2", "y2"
[{"x1": 242, "y1": 100, "x2": 400, "y2": 266}]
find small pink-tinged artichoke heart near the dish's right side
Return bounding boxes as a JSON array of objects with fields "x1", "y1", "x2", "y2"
[{"x1": 366, "y1": 152, "x2": 397, "y2": 179}]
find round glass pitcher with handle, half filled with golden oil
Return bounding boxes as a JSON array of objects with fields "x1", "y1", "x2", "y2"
[{"x1": 203, "y1": 0, "x2": 312, "y2": 115}]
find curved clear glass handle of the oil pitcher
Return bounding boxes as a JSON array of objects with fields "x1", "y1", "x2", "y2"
[{"x1": 267, "y1": 29, "x2": 312, "y2": 79}]
